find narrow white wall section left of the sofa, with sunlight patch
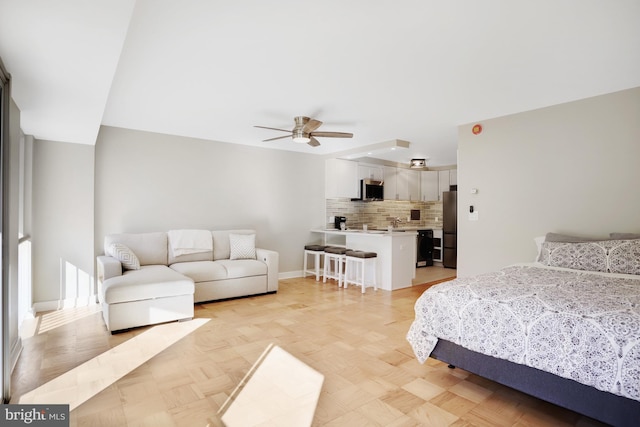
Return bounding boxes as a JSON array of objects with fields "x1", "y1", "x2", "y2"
[{"x1": 32, "y1": 140, "x2": 95, "y2": 311}]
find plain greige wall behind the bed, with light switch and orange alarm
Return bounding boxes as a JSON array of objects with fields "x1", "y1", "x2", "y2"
[{"x1": 458, "y1": 88, "x2": 640, "y2": 276}]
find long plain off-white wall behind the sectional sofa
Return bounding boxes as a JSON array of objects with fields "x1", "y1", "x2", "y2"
[{"x1": 95, "y1": 126, "x2": 325, "y2": 277}]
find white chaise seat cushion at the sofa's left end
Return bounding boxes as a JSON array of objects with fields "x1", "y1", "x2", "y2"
[{"x1": 100, "y1": 265, "x2": 194, "y2": 304}]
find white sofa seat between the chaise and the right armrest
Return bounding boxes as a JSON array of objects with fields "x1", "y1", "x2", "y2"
[{"x1": 171, "y1": 259, "x2": 267, "y2": 283}]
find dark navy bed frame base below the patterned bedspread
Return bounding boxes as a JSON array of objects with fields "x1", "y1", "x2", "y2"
[{"x1": 431, "y1": 339, "x2": 640, "y2": 427}]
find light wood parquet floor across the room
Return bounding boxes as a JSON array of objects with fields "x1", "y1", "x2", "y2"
[{"x1": 12, "y1": 267, "x2": 602, "y2": 427}]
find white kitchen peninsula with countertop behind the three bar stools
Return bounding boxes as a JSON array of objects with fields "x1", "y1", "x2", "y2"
[{"x1": 311, "y1": 229, "x2": 417, "y2": 291}]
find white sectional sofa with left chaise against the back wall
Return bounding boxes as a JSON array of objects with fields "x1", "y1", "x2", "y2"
[{"x1": 97, "y1": 230, "x2": 278, "y2": 332}]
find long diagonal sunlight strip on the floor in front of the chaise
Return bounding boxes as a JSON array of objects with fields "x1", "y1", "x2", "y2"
[{"x1": 18, "y1": 319, "x2": 209, "y2": 410}]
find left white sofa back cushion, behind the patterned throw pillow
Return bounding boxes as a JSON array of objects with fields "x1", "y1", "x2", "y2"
[{"x1": 104, "y1": 231, "x2": 168, "y2": 265}]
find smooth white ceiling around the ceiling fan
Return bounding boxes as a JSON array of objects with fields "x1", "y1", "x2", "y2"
[{"x1": 0, "y1": 0, "x2": 640, "y2": 166}]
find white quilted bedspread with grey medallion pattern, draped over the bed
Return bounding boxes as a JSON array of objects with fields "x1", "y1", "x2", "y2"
[{"x1": 407, "y1": 265, "x2": 640, "y2": 401}]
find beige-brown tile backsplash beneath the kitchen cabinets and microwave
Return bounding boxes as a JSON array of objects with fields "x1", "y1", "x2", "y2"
[{"x1": 326, "y1": 199, "x2": 442, "y2": 229}]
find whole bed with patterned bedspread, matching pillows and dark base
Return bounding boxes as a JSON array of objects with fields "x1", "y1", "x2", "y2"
[{"x1": 407, "y1": 236, "x2": 640, "y2": 425}]
